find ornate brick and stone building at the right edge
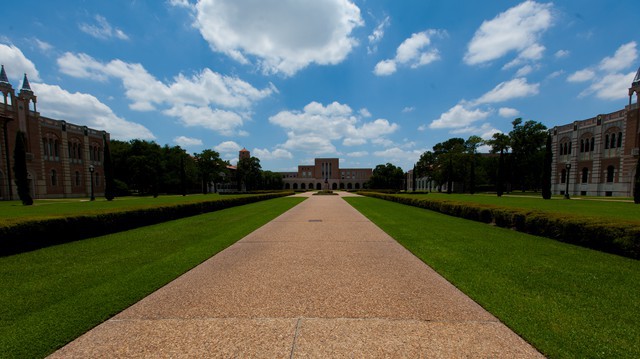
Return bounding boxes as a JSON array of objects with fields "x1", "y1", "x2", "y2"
[{"x1": 552, "y1": 68, "x2": 640, "y2": 196}]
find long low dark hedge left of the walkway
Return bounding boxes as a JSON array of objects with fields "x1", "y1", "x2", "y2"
[{"x1": 0, "y1": 192, "x2": 293, "y2": 256}]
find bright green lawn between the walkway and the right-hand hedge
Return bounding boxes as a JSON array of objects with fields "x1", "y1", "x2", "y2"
[{"x1": 345, "y1": 194, "x2": 640, "y2": 358}]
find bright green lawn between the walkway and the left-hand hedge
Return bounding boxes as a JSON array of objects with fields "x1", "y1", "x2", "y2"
[{"x1": 0, "y1": 197, "x2": 304, "y2": 358}]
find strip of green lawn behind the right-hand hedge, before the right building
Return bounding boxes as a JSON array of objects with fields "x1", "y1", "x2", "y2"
[{"x1": 401, "y1": 192, "x2": 640, "y2": 223}]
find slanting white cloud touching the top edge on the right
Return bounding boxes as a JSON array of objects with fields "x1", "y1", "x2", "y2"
[{"x1": 464, "y1": 1, "x2": 553, "y2": 65}]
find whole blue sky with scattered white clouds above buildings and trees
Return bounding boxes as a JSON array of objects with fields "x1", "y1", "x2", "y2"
[{"x1": 0, "y1": 0, "x2": 640, "y2": 171}]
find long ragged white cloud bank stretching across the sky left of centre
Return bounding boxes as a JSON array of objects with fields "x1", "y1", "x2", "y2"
[{"x1": 58, "y1": 52, "x2": 277, "y2": 135}]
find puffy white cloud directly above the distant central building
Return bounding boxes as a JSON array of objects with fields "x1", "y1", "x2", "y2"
[{"x1": 269, "y1": 101, "x2": 398, "y2": 154}]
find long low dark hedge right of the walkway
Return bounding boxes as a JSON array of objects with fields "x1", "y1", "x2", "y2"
[{"x1": 359, "y1": 192, "x2": 640, "y2": 259}]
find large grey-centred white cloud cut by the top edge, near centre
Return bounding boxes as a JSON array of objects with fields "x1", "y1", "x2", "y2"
[{"x1": 195, "y1": 0, "x2": 364, "y2": 76}]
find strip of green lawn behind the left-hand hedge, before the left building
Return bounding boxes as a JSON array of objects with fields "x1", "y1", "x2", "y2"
[{"x1": 0, "y1": 193, "x2": 264, "y2": 225}]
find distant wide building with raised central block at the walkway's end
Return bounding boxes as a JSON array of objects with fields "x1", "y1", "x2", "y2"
[{"x1": 281, "y1": 158, "x2": 373, "y2": 190}]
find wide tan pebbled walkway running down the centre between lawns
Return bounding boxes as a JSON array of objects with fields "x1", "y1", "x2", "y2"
[{"x1": 51, "y1": 193, "x2": 542, "y2": 358}]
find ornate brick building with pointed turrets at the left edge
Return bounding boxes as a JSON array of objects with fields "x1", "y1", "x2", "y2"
[{"x1": 0, "y1": 66, "x2": 109, "y2": 200}]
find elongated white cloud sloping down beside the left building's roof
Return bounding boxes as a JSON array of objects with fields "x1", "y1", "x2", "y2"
[{"x1": 31, "y1": 83, "x2": 155, "y2": 140}]
